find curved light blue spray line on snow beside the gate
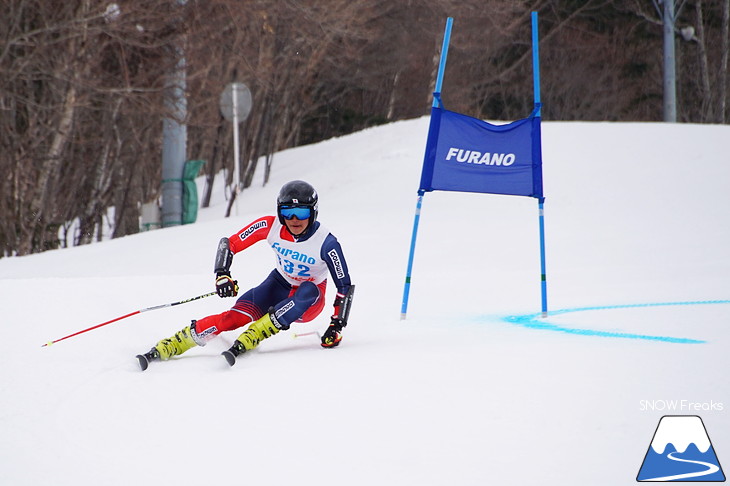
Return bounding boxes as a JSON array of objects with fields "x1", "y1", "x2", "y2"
[{"x1": 502, "y1": 300, "x2": 730, "y2": 344}]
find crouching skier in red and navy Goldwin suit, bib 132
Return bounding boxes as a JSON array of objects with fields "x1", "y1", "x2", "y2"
[{"x1": 137, "y1": 180, "x2": 355, "y2": 371}]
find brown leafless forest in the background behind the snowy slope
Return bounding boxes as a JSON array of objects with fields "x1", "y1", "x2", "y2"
[{"x1": 0, "y1": 0, "x2": 730, "y2": 257}]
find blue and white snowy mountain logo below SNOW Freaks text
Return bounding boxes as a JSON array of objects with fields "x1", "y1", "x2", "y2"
[{"x1": 636, "y1": 415, "x2": 725, "y2": 482}]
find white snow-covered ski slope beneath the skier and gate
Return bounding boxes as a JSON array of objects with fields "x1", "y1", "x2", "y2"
[{"x1": 0, "y1": 118, "x2": 730, "y2": 486}]
